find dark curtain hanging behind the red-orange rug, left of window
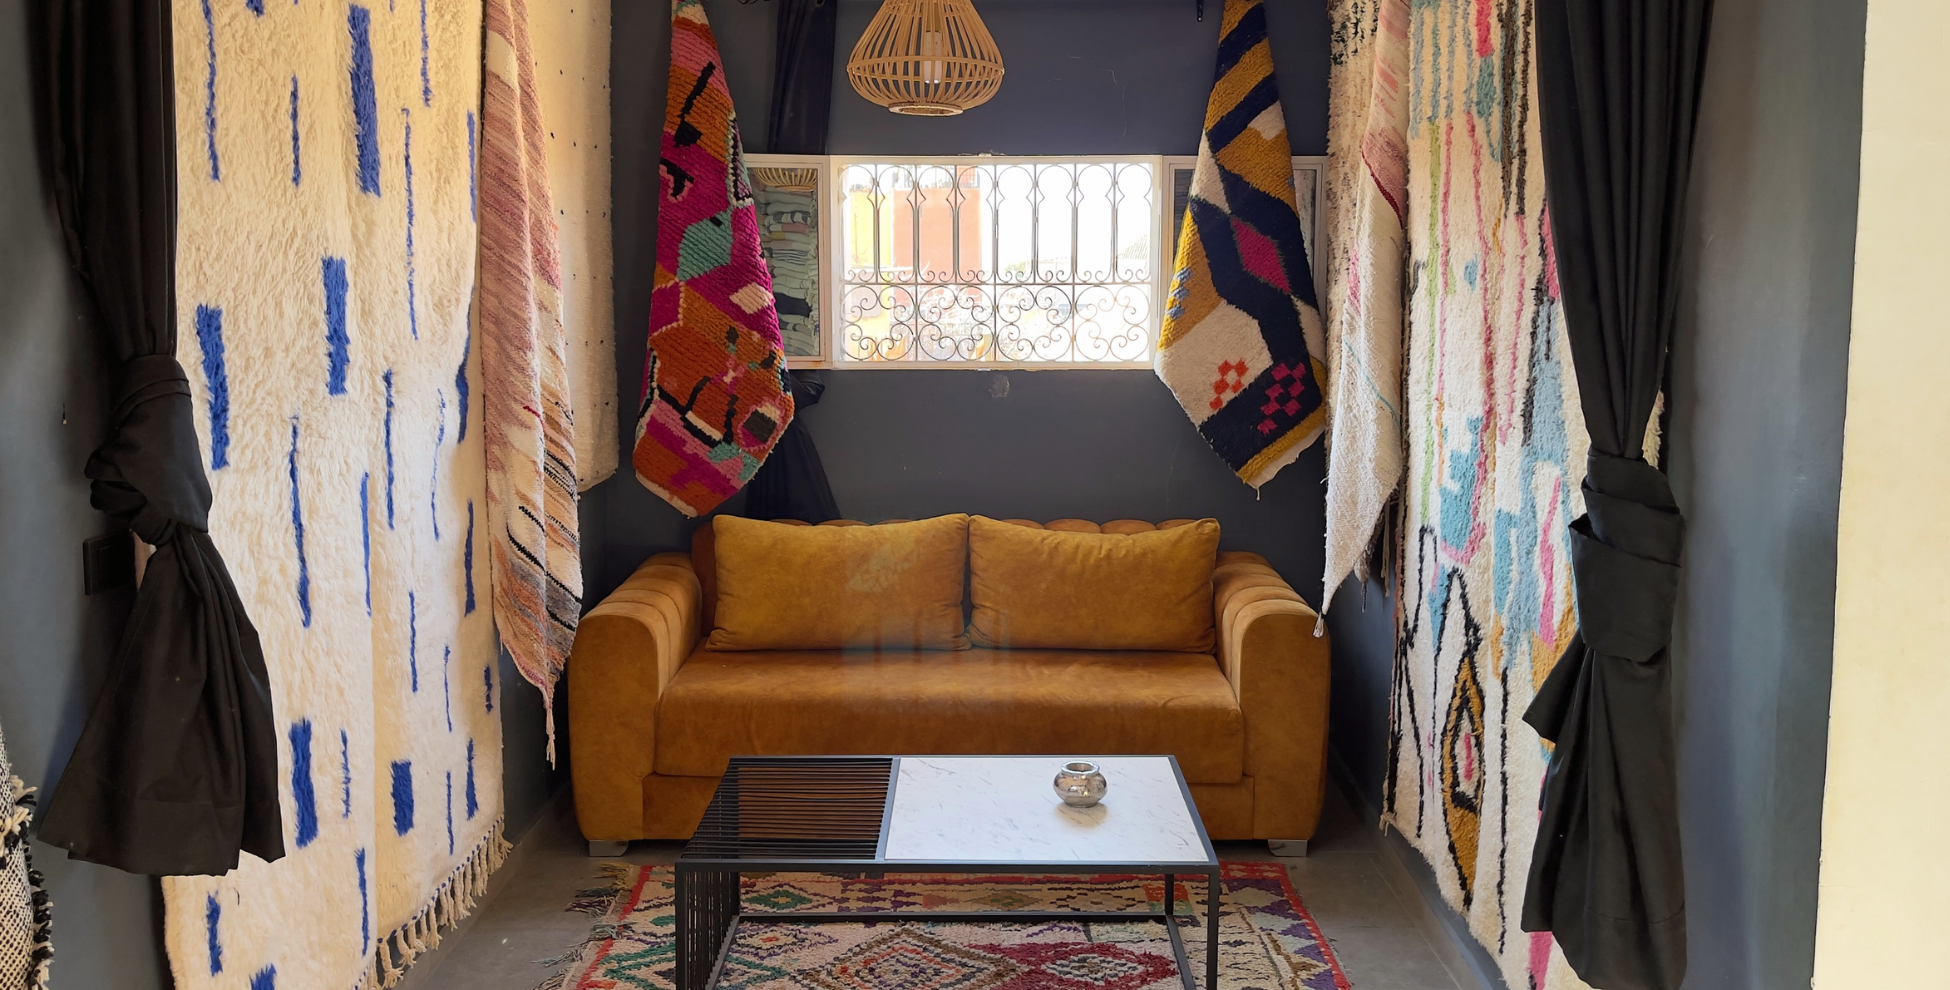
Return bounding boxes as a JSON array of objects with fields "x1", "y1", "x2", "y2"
[{"x1": 745, "y1": 0, "x2": 840, "y2": 522}]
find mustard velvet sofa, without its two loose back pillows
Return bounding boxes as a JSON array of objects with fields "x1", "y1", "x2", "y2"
[{"x1": 567, "y1": 518, "x2": 1328, "y2": 856}]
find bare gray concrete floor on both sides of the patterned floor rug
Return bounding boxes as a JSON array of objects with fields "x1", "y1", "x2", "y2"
[{"x1": 400, "y1": 785, "x2": 1478, "y2": 990}]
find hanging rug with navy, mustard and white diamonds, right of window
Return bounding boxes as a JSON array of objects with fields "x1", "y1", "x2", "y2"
[{"x1": 1156, "y1": 0, "x2": 1326, "y2": 487}]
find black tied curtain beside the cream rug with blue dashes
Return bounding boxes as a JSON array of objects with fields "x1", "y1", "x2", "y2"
[{"x1": 39, "y1": 0, "x2": 285, "y2": 875}]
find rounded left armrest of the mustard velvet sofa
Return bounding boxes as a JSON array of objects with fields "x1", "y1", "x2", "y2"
[{"x1": 569, "y1": 553, "x2": 702, "y2": 840}]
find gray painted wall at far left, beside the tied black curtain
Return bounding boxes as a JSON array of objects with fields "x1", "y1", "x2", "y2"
[{"x1": 0, "y1": 0, "x2": 168, "y2": 990}]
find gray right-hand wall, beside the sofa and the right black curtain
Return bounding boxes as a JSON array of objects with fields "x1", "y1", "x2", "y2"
[{"x1": 1328, "y1": 0, "x2": 1866, "y2": 990}]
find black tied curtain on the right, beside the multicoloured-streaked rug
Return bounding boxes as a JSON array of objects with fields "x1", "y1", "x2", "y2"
[{"x1": 1523, "y1": 0, "x2": 1710, "y2": 990}]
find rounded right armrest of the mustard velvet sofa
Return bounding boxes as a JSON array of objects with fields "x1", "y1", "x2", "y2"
[{"x1": 1213, "y1": 553, "x2": 1328, "y2": 838}]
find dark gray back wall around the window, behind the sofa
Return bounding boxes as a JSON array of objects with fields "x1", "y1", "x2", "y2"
[{"x1": 581, "y1": 0, "x2": 1328, "y2": 604}]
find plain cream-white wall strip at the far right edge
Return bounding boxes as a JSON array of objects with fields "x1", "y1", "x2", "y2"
[{"x1": 1815, "y1": 0, "x2": 1950, "y2": 990}]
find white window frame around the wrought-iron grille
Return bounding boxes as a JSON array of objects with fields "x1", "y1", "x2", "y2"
[{"x1": 745, "y1": 154, "x2": 1328, "y2": 370}]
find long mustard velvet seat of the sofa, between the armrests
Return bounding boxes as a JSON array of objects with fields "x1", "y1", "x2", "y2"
[{"x1": 655, "y1": 649, "x2": 1246, "y2": 783}]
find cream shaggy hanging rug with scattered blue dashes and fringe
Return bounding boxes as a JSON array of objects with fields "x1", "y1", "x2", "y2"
[{"x1": 162, "y1": 0, "x2": 507, "y2": 990}]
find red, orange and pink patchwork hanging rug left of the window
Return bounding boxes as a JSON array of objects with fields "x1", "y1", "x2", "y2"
[{"x1": 632, "y1": 0, "x2": 792, "y2": 516}]
